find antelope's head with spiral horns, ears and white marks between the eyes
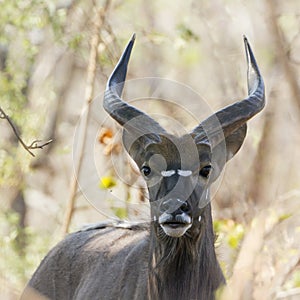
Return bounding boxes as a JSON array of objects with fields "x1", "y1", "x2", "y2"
[{"x1": 104, "y1": 36, "x2": 265, "y2": 238}]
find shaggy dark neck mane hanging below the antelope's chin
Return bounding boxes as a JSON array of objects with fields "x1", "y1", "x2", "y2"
[{"x1": 149, "y1": 207, "x2": 224, "y2": 300}]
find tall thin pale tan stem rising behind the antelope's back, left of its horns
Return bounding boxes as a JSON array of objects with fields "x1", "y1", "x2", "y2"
[{"x1": 62, "y1": 0, "x2": 111, "y2": 235}]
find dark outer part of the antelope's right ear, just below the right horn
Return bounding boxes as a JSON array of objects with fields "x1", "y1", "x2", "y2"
[{"x1": 225, "y1": 123, "x2": 247, "y2": 161}]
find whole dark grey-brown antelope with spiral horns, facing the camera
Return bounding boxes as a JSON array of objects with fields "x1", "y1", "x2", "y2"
[{"x1": 23, "y1": 36, "x2": 265, "y2": 300}]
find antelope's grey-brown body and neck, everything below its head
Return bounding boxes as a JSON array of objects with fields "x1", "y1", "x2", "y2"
[{"x1": 24, "y1": 213, "x2": 224, "y2": 300}]
